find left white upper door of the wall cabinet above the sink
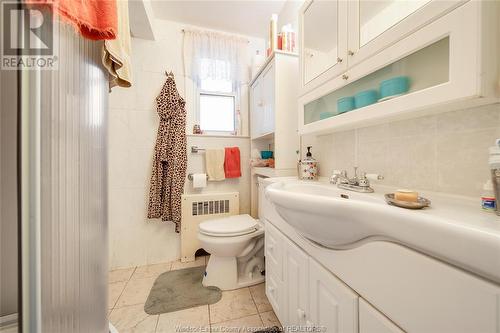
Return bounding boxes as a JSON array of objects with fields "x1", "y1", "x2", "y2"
[{"x1": 299, "y1": 0, "x2": 347, "y2": 93}]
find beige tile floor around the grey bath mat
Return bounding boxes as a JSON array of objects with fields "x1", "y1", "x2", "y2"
[{"x1": 108, "y1": 257, "x2": 280, "y2": 333}]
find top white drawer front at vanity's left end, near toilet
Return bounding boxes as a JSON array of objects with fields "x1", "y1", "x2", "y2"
[{"x1": 265, "y1": 222, "x2": 284, "y2": 281}]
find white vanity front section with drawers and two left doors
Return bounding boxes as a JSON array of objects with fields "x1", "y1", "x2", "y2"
[{"x1": 265, "y1": 223, "x2": 358, "y2": 333}]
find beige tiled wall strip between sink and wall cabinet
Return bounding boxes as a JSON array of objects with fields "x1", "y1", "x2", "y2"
[{"x1": 302, "y1": 104, "x2": 500, "y2": 197}]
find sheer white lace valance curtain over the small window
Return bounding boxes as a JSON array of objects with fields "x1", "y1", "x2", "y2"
[{"x1": 184, "y1": 30, "x2": 249, "y2": 87}]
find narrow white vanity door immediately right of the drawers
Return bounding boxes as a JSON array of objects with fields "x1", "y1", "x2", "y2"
[{"x1": 284, "y1": 237, "x2": 309, "y2": 325}]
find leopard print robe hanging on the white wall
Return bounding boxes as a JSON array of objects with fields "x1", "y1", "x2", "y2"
[{"x1": 148, "y1": 75, "x2": 187, "y2": 232}]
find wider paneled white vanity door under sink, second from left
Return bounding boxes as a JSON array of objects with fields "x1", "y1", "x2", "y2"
[{"x1": 307, "y1": 259, "x2": 358, "y2": 333}]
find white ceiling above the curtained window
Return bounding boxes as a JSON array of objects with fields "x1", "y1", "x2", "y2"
[{"x1": 151, "y1": 0, "x2": 285, "y2": 38}]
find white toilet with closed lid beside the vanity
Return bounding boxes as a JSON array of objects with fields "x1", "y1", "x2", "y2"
[{"x1": 198, "y1": 214, "x2": 265, "y2": 290}]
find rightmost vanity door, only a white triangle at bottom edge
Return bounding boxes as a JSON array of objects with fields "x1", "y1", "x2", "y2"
[{"x1": 359, "y1": 298, "x2": 404, "y2": 333}]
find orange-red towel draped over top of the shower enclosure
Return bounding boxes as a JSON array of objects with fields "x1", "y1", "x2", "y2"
[{"x1": 28, "y1": 0, "x2": 120, "y2": 40}]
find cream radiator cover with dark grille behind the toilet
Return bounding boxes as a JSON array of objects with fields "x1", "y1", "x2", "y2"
[{"x1": 181, "y1": 192, "x2": 240, "y2": 262}]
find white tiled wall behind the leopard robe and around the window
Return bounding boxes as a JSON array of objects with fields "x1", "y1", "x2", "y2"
[{"x1": 109, "y1": 20, "x2": 264, "y2": 269}]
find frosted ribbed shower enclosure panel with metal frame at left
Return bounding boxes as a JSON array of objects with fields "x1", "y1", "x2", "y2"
[{"x1": 0, "y1": 4, "x2": 108, "y2": 333}]
